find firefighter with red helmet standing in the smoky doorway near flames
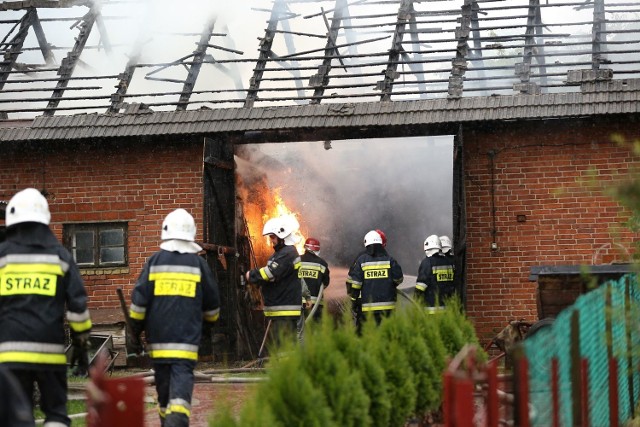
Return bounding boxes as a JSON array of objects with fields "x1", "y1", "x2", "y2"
[{"x1": 298, "y1": 237, "x2": 330, "y2": 320}]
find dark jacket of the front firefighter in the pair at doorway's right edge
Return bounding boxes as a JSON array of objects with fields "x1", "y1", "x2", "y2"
[{"x1": 416, "y1": 254, "x2": 455, "y2": 307}]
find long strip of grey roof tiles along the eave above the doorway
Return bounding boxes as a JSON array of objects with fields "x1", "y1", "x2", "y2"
[{"x1": 0, "y1": 80, "x2": 640, "y2": 143}]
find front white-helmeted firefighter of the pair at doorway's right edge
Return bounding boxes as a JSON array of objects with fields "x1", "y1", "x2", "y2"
[{"x1": 415, "y1": 234, "x2": 455, "y2": 313}]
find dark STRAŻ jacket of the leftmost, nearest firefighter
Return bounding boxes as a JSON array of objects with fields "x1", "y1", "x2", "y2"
[{"x1": 0, "y1": 223, "x2": 91, "y2": 369}]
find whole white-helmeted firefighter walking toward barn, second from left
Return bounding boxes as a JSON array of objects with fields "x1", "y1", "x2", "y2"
[{"x1": 129, "y1": 209, "x2": 220, "y2": 427}]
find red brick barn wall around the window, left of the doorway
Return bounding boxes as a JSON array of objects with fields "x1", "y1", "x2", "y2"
[{"x1": 0, "y1": 138, "x2": 203, "y2": 308}]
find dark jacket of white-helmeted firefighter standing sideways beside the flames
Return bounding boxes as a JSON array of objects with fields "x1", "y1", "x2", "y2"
[{"x1": 249, "y1": 245, "x2": 302, "y2": 317}]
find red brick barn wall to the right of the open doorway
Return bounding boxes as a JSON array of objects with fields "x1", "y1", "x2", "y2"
[{"x1": 464, "y1": 121, "x2": 640, "y2": 338}]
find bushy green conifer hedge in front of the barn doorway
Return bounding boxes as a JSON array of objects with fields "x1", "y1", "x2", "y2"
[{"x1": 210, "y1": 301, "x2": 486, "y2": 427}]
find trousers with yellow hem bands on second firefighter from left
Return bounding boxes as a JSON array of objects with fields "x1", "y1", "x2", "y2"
[{"x1": 153, "y1": 359, "x2": 196, "y2": 427}]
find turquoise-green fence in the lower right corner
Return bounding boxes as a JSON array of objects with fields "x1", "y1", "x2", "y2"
[{"x1": 522, "y1": 275, "x2": 640, "y2": 427}]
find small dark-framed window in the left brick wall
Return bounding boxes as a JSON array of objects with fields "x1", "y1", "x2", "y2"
[{"x1": 64, "y1": 223, "x2": 127, "y2": 267}]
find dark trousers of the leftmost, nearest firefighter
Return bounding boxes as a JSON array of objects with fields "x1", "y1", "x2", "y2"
[{"x1": 10, "y1": 368, "x2": 71, "y2": 426}]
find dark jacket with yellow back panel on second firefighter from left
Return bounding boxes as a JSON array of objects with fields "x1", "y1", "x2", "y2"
[{"x1": 130, "y1": 249, "x2": 220, "y2": 363}]
